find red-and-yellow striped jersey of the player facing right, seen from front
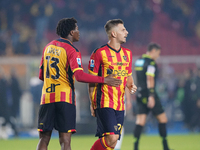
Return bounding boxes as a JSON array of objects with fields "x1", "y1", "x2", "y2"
[{"x1": 88, "y1": 44, "x2": 132, "y2": 111}]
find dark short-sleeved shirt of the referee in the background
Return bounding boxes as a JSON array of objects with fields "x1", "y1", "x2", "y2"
[{"x1": 135, "y1": 54, "x2": 157, "y2": 93}]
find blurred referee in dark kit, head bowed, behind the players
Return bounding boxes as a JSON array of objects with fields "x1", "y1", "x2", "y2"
[{"x1": 134, "y1": 43, "x2": 169, "y2": 150}]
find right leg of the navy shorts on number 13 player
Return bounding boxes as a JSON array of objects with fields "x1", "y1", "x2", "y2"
[{"x1": 55, "y1": 102, "x2": 76, "y2": 133}]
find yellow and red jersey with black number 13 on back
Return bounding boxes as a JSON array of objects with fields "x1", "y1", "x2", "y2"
[{"x1": 40, "y1": 38, "x2": 83, "y2": 105}]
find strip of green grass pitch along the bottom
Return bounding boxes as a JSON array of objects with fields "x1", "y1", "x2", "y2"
[{"x1": 0, "y1": 134, "x2": 200, "y2": 150}]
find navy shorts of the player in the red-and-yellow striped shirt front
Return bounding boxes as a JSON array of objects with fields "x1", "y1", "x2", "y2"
[{"x1": 95, "y1": 108, "x2": 124, "y2": 138}]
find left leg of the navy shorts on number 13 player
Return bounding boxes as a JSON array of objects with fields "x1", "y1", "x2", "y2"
[{"x1": 38, "y1": 103, "x2": 55, "y2": 132}]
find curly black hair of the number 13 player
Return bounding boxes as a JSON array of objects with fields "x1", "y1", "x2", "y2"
[{"x1": 56, "y1": 18, "x2": 77, "y2": 38}]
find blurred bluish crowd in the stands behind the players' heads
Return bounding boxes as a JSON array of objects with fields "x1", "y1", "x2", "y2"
[{"x1": 0, "y1": 0, "x2": 200, "y2": 56}]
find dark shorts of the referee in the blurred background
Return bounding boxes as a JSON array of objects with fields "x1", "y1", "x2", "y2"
[{"x1": 136, "y1": 95, "x2": 164, "y2": 116}]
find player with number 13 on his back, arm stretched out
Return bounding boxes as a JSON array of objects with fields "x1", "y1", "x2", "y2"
[{"x1": 37, "y1": 18, "x2": 121, "y2": 150}]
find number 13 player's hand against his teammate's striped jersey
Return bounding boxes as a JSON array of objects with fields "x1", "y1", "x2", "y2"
[{"x1": 104, "y1": 74, "x2": 122, "y2": 87}]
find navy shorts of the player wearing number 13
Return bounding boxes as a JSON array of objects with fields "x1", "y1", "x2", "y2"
[{"x1": 38, "y1": 102, "x2": 76, "y2": 133}]
